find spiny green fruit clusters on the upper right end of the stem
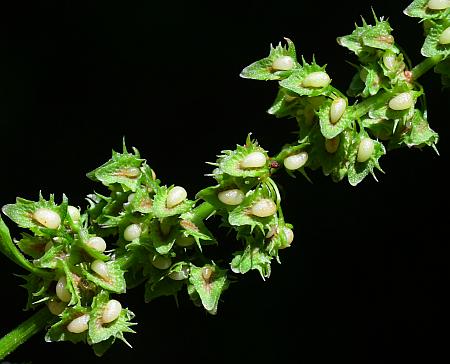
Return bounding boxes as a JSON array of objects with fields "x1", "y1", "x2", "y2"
[{"x1": 241, "y1": 7, "x2": 442, "y2": 185}]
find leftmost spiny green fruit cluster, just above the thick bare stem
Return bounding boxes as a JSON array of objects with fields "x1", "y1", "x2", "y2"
[{"x1": 2, "y1": 191, "x2": 140, "y2": 350}]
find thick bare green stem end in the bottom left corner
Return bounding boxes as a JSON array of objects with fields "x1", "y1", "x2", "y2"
[{"x1": 0, "y1": 306, "x2": 53, "y2": 360}]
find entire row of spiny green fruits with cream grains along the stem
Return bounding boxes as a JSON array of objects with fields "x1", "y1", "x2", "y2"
[{"x1": 3, "y1": 0, "x2": 450, "y2": 356}]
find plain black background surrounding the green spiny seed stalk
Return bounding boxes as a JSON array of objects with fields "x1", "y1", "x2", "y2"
[{"x1": 0, "y1": 0, "x2": 450, "y2": 363}]
